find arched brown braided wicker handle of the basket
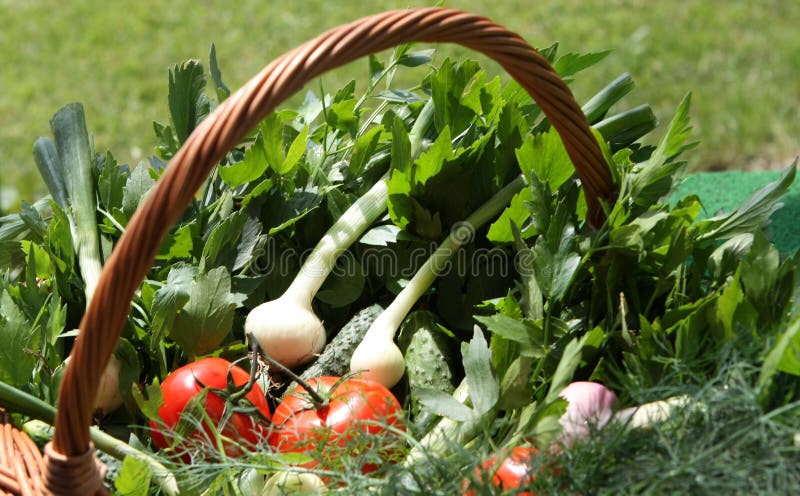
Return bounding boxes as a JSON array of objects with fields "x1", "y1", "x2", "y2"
[{"x1": 51, "y1": 8, "x2": 613, "y2": 494}]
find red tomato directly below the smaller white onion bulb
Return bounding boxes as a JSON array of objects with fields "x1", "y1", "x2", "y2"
[{"x1": 269, "y1": 376, "x2": 405, "y2": 472}]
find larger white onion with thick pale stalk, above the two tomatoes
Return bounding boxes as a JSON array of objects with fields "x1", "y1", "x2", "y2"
[{"x1": 244, "y1": 100, "x2": 433, "y2": 368}]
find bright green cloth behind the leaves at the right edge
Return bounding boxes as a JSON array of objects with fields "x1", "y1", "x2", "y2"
[{"x1": 673, "y1": 171, "x2": 800, "y2": 254}]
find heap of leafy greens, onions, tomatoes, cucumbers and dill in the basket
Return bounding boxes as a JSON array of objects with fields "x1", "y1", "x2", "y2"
[{"x1": 0, "y1": 36, "x2": 800, "y2": 495}]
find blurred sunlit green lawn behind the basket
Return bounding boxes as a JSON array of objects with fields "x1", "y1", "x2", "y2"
[{"x1": 0, "y1": 0, "x2": 800, "y2": 203}]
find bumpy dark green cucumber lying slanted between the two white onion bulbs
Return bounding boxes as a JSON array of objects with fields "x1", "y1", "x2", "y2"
[{"x1": 284, "y1": 304, "x2": 383, "y2": 394}]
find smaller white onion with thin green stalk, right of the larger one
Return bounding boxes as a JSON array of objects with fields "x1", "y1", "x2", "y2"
[{"x1": 350, "y1": 176, "x2": 526, "y2": 387}]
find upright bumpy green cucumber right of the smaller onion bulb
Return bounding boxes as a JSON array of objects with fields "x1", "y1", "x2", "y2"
[{"x1": 398, "y1": 310, "x2": 461, "y2": 423}]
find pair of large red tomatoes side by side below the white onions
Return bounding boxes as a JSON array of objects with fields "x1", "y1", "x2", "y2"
[{"x1": 150, "y1": 358, "x2": 404, "y2": 472}]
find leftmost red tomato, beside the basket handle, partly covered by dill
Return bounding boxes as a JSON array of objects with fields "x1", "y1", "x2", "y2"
[{"x1": 150, "y1": 358, "x2": 270, "y2": 461}]
